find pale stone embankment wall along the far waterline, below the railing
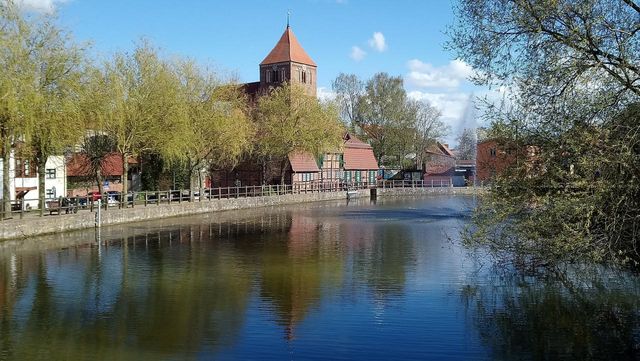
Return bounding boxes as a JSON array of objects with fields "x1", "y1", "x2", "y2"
[{"x1": 0, "y1": 187, "x2": 482, "y2": 241}]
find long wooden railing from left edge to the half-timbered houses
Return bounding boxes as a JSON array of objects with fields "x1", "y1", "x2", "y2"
[{"x1": 0, "y1": 181, "x2": 375, "y2": 220}]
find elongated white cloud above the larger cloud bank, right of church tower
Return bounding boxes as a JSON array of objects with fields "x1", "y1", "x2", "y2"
[{"x1": 407, "y1": 59, "x2": 475, "y2": 89}]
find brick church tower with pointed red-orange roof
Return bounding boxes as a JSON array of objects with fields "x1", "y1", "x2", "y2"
[{"x1": 260, "y1": 24, "x2": 318, "y2": 96}]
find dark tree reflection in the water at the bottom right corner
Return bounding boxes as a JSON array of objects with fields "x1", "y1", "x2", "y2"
[{"x1": 462, "y1": 270, "x2": 640, "y2": 360}]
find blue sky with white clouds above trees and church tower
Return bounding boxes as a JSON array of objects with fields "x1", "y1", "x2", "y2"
[{"x1": 16, "y1": 0, "x2": 496, "y2": 144}]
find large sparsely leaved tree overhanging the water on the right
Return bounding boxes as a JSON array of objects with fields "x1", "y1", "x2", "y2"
[{"x1": 449, "y1": 0, "x2": 640, "y2": 269}]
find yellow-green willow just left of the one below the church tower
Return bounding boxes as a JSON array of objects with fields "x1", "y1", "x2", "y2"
[{"x1": 176, "y1": 61, "x2": 253, "y2": 188}]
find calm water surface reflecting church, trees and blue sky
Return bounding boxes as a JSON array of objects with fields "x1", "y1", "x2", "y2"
[{"x1": 0, "y1": 196, "x2": 640, "y2": 360}]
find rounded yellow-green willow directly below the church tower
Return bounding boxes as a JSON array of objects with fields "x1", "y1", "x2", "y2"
[{"x1": 256, "y1": 84, "x2": 344, "y2": 184}]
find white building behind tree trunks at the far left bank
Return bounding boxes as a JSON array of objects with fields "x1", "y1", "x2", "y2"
[{"x1": 0, "y1": 152, "x2": 67, "y2": 210}]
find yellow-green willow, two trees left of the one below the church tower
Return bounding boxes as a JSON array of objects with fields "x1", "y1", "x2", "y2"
[{"x1": 93, "y1": 42, "x2": 182, "y2": 192}]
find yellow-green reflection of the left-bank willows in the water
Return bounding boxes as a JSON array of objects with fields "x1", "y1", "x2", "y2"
[{"x1": 0, "y1": 225, "x2": 251, "y2": 360}]
